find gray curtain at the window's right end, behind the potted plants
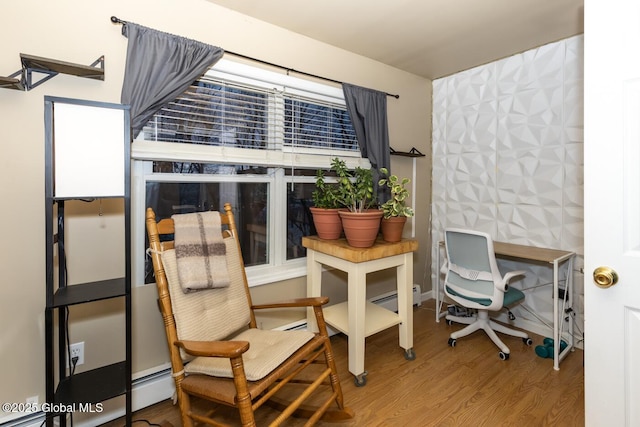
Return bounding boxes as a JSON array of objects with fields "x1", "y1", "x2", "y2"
[{"x1": 342, "y1": 83, "x2": 391, "y2": 201}]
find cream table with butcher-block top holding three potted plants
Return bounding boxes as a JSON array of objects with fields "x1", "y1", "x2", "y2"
[{"x1": 302, "y1": 236, "x2": 418, "y2": 386}]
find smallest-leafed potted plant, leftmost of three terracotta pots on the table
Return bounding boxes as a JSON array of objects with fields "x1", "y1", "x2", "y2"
[{"x1": 309, "y1": 169, "x2": 342, "y2": 240}]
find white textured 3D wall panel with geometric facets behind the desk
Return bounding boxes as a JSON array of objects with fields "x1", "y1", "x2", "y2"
[{"x1": 432, "y1": 36, "x2": 583, "y2": 342}]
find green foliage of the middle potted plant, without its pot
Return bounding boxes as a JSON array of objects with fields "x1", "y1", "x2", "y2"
[{"x1": 331, "y1": 157, "x2": 375, "y2": 212}]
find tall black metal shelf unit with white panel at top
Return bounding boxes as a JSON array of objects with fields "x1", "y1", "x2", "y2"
[{"x1": 45, "y1": 96, "x2": 132, "y2": 427}]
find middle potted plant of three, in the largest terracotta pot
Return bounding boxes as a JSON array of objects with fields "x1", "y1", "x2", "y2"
[{"x1": 331, "y1": 157, "x2": 382, "y2": 248}]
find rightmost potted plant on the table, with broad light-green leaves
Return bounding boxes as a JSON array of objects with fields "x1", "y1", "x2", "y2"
[{"x1": 378, "y1": 168, "x2": 414, "y2": 242}]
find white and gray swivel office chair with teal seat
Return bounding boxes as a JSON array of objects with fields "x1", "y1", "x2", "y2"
[{"x1": 443, "y1": 228, "x2": 533, "y2": 360}]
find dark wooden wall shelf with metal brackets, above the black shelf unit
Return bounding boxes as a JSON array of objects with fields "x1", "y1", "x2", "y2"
[{"x1": 0, "y1": 53, "x2": 104, "y2": 90}]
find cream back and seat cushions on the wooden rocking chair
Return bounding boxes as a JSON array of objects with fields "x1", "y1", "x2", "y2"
[{"x1": 162, "y1": 238, "x2": 314, "y2": 381}]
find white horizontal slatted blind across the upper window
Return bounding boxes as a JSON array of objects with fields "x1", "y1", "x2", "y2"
[{"x1": 144, "y1": 76, "x2": 358, "y2": 152}]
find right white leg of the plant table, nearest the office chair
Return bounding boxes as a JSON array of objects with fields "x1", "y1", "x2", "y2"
[{"x1": 396, "y1": 252, "x2": 413, "y2": 358}]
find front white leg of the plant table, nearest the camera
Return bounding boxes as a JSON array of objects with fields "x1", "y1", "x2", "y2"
[{"x1": 347, "y1": 263, "x2": 367, "y2": 385}]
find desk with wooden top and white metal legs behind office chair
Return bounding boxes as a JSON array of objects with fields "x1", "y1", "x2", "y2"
[{"x1": 435, "y1": 241, "x2": 575, "y2": 370}]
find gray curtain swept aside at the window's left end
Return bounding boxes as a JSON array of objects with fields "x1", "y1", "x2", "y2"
[{"x1": 120, "y1": 22, "x2": 224, "y2": 138}]
